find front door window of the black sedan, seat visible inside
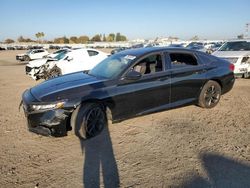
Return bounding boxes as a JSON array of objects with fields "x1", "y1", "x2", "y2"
[{"x1": 133, "y1": 54, "x2": 163, "y2": 75}]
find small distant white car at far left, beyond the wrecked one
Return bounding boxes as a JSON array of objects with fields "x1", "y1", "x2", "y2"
[{"x1": 16, "y1": 49, "x2": 49, "y2": 61}]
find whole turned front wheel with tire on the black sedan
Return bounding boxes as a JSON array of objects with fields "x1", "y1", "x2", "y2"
[{"x1": 70, "y1": 103, "x2": 107, "y2": 140}]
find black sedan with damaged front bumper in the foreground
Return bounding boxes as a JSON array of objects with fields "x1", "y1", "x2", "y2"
[{"x1": 22, "y1": 48, "x2": 234, "y2": 139}]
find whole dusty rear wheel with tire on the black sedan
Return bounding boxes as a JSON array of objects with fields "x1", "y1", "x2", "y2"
[{"x1": 198, "y1": 80, "x2": 221, "y2": 108}]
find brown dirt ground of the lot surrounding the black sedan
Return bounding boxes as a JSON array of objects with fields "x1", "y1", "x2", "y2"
[{"x1": 0, "y1": 51, "x2": 250, "y2": 188}]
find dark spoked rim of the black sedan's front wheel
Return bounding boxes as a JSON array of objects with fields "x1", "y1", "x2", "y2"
[{"x1": 85, "y1": 107, "x2": 105, "y2": 137}]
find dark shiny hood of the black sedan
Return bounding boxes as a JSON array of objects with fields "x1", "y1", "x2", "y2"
[{"x1": 30, "y1": 72, "x2": 104, "y2": 102}]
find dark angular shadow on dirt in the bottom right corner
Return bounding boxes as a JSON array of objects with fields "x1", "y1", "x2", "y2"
[{"x1": 181, "y1": 153, "x2": 250, "y2": 188}]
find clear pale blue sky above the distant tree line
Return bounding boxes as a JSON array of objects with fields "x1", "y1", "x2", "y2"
[{"x1": 0, "y1": 0, "x2": 250, "y2": 41}]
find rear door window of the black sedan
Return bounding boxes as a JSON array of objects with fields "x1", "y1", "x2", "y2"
[{"x1": 169, "y1": 53, "x2": 198, "y2": 68}]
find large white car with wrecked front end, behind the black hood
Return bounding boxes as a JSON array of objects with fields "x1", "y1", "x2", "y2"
[{"x1": 26, "y1": 48, "x2": 109, "y2": 80}]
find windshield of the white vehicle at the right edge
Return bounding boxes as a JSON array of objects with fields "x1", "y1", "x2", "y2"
[{"x1": 219, "y1": 41, "x2": 250, "y2": 51}]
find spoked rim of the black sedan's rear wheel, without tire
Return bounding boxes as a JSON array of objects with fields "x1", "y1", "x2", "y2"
[{"x1": 205, "y1": 85, "x2": 220, "y2": 106}]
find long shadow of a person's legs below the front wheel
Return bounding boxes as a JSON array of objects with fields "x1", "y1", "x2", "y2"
[{"x1": 79, "y1": 127, "x2": 120, "y2": 188}]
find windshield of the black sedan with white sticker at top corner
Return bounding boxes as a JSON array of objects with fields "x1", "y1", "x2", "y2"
[{"x1": 89, "y1": 54, "x2": 136, "y2": 79}]
